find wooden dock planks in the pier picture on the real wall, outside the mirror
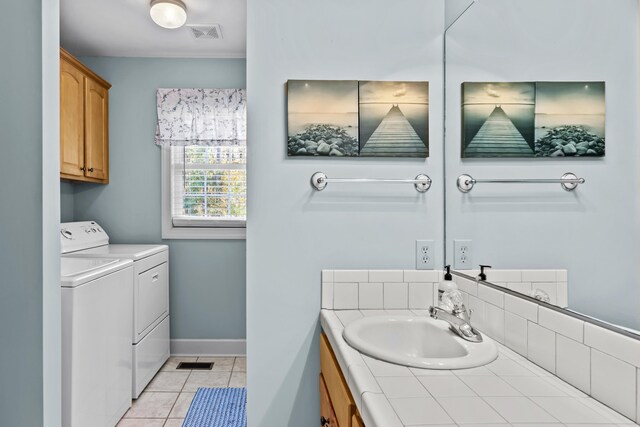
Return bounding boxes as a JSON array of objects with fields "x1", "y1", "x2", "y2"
[{"x1": 360, "y1": 105, "x2": 429, "y2": 157}]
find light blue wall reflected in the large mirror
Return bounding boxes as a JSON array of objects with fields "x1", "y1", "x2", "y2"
[{"x1": 446, "y1": 0, "x2": 640, "y2": 330}]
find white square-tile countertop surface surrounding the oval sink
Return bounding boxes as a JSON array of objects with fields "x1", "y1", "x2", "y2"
[{"x1": 320, "y1": 309, "x2": 638, "y2": 427}]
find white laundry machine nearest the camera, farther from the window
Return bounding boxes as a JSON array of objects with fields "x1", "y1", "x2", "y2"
[{"x1": 60, "y1": 257, "x2": 133, "y2": 427}]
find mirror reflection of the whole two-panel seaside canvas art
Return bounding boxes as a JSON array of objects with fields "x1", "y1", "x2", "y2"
[{"x1": 461, "y1": 82, "x2": 605, "y2": 158}]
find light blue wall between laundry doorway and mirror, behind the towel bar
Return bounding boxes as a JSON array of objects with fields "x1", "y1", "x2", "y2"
[{"x1": 247, "y1": 0, "x2": 444, "y2": 427}]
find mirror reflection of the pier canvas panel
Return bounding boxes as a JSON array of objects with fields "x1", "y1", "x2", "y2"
[{"x1": 462, "y1": 82, "x2": 536, "y2": 158}]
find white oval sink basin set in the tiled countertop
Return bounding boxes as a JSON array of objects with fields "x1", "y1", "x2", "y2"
[{"x1": 342, "y1": 315, "x2": 498, "y2": 369}]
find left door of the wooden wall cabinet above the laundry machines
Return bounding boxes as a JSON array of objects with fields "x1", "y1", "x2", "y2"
[{"x1": 60, "y1": 60, "x2": 85, "y2": 176}]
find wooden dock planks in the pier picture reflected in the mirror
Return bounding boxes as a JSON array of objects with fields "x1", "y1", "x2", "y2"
[{"x1": 464, "y1": 106, "x2": 533, "y2": 157}]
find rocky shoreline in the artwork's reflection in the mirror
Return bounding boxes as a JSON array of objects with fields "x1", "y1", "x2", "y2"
[{"x1": 535, "y1": 126, "x2": 604, "y2": 157}]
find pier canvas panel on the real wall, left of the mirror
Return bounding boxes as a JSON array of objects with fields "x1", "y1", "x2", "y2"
[{"x1": 358, "y1": 81, "x2": 429, "y2": 157}]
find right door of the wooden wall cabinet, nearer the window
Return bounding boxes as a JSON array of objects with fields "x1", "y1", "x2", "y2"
[{"x1": 85, "y1": 78, "x2": 109, "y2": 181}]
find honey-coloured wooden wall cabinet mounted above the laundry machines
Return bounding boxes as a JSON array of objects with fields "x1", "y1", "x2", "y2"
[{"x1": 60, "y1": 48, "x2": 111, "y2": 184}]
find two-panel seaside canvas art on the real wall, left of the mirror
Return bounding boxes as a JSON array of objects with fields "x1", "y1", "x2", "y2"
[{"x1": 287, "y1": 80, "x2": 429, "y2": 158}]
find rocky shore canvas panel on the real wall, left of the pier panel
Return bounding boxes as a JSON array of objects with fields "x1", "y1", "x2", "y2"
[{"x1": 287, "y1": 80, "x2": 360, "y2": 157}]
